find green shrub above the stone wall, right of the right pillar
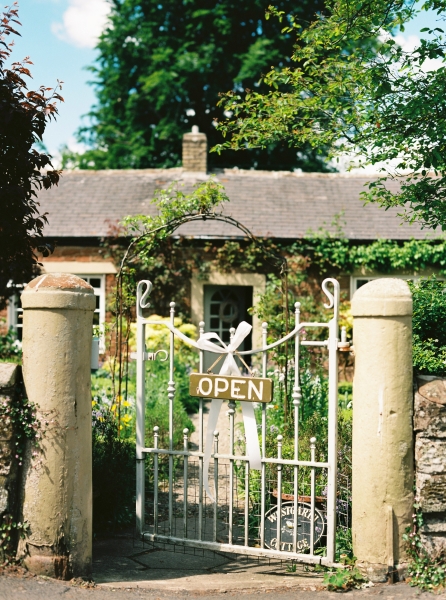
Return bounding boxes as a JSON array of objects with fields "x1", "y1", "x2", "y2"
[{"x1": 409, "y1": 277, "x2": 446, "y2": 377}]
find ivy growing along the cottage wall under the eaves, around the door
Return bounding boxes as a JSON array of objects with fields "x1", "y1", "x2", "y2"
[{"x1": 104, "y1": 217, "x2": 446, "y2": 352}]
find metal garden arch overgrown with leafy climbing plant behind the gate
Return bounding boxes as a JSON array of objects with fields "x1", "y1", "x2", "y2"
[{"x1": 111, "y1": 178, "x2": 289, "y2": 432}]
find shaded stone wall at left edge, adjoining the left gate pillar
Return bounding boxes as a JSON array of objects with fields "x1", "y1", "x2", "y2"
[{"x1": 0, "y1": 363, "x2": 21, "y2": 562}]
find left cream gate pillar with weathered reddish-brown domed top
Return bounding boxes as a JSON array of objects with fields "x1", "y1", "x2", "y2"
[{"x1": 19, "y1": 273, "x2": 95, "y2": 579}]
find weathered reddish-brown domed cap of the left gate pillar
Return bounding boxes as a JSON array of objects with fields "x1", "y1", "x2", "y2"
[{"x1": 21, "y1": 273, "x2": 96, "y2": 310}]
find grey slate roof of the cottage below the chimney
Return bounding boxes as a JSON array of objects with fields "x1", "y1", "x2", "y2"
[{"x1": 39, "y1": 168, "x2": 434, "y2": 242}]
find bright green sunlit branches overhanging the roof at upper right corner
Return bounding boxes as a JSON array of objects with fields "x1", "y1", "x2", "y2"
[{"x1": 217, "y1": 0, "x2": 446, "y2": 229}]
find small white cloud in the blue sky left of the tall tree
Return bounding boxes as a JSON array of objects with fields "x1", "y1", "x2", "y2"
[{"x1": 51, "y1": 0, "x2": 110, "y2": 48}]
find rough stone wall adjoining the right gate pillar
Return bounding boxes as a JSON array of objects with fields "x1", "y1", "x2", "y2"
[{"x1": 414, "y1": 376, "x2": 446, "y2": 554}]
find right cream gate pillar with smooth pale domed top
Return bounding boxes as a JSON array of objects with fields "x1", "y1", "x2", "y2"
[{"x1": 352, "y1": 278, "x2": 414, "y2": 582}]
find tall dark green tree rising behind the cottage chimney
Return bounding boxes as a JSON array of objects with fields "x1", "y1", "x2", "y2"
[{"x1": 75, "y1": 0, "x2": 332, "y2": 171}]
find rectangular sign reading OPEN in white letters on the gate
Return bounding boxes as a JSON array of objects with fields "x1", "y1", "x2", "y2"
[{"x1": 189, "y1": 373, "x2": 273, "y2": 402}]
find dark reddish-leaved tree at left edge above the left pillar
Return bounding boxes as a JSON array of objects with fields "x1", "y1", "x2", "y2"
[{"x1": 0, "y1": 5, "x2": 62, "y2": 304}]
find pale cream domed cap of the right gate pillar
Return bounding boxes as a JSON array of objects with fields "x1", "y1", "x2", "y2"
[{"x1": 352, "y1": 277, "x2": 412, "y2": 317}]
